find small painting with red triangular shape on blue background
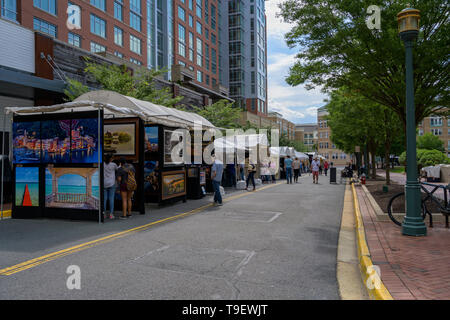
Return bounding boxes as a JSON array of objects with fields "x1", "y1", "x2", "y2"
[{"x1": 16, "y1": 167, "x2": 39, "y2": 207}]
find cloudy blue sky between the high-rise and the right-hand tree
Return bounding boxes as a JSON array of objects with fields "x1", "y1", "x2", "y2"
[{"x1": 266, "y1": 0, "x2": 326, "y2": 124}]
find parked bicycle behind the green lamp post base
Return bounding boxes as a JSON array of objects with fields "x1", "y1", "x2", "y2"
[{"x1": 388, "y1": 182, "x2": 450, "y2": 228}]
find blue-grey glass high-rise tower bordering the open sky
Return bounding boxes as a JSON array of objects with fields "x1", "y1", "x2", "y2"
[{"x1": 219, "y1": 0, "x2": 268, "y2": 116}]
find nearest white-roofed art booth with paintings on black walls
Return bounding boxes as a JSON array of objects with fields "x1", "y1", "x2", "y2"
[{"x1": 6, "y1": 90, "x2": 214, "y2": 221}]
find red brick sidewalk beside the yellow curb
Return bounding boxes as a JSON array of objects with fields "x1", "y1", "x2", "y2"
[{"x1": 356, "y1": 186, "x2": 450, "y2": 300}]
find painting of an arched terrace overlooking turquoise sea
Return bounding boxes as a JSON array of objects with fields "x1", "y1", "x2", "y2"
[{"x1": 45, "y1": 166, "x2": 100, "y2": 210}]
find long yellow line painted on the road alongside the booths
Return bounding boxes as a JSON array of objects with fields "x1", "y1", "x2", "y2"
[{"x1": 0, "y1": 182, "x2": 282, "y2": 276}]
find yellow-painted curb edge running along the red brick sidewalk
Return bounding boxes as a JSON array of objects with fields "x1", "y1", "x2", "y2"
[{"x1": 352, "y1": 184, "x2": 394, "y2": 300}]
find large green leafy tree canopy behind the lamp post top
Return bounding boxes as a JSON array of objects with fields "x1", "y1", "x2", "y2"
[{"x1": 280, "y1": 0, "x2": 450, "y2": 129}]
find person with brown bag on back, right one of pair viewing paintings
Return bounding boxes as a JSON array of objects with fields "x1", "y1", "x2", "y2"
[{"x1": 117, "y1": 158, "x2": 137, "y2": 219}]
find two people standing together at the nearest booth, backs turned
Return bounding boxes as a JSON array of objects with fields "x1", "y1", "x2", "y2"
[{"x1": 103, "y1": 154, "x2": 137, "y2": 219}]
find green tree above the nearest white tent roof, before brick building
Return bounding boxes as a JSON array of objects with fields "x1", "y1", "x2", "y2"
[{"x1": 64, "y1": 61, "x2": 183, "y2": 107}]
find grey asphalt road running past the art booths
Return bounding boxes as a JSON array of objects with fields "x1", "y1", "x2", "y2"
[{"x1": 0, "y1": 175, "x2": 345, "y2": 300}]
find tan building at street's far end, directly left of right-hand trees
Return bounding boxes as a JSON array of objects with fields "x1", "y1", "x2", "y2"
[{"x1": 317, "y1": 107, "x2": 352, "y2": 166}]
